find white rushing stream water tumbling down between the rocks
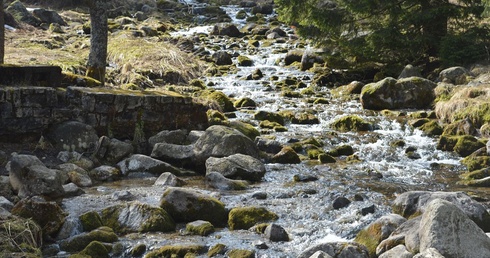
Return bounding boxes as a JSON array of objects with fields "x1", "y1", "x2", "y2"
[{"x1": 58, "y1": 1, "x2": 474, "y2": 257}]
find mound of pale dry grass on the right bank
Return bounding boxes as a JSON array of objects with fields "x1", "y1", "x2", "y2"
[{"x1": 435, "y1": 84, "x2": 490, "y2": 127}]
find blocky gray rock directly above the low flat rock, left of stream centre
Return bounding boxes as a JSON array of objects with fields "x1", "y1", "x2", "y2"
[{"x1": 150, "y1": 142, "x2": 194, "y2": 167}]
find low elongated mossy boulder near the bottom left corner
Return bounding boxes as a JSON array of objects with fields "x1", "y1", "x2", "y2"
[{"x1": 60, "y1": 227, "x2": 118, "y2": 252}]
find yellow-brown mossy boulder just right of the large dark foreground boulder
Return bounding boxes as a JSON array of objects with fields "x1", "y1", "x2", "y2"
[{"x1": 228, "y1": 207, "x2": 279, "y2": 230}]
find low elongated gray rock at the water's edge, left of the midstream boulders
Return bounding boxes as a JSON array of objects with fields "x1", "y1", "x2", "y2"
[{"x1": 117, "y1": 154, "x2": 181, "y2": 176}]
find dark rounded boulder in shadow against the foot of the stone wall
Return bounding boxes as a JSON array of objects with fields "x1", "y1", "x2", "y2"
[{"x1": 47, "y1": 121, "x2": 99, "y2": 153}]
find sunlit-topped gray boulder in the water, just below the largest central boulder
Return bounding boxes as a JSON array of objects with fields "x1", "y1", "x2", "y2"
[{"x1": 206, "y1": 153, "x2": 265, "y2": 181}]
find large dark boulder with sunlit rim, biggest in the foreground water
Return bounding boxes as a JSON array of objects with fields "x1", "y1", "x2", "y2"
[{"x1": 160, "y1": 187, "x2": 228, "y2": 226}]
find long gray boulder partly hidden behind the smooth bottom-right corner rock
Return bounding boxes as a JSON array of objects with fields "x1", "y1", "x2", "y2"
[{"x1": 393, "y1": 191, "x2": 490, "y2": 232}]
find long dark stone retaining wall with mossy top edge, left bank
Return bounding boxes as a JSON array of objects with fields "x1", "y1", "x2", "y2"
[{"x1": 0, "y1": 86, "x2": 207, "y2": 142}]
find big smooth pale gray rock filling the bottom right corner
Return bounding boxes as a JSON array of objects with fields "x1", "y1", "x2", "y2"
[{"x1": 419, "y1": 199, "x2": 490, "y2": 258}]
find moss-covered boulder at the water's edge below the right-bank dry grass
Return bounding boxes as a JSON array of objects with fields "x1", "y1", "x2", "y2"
[{"x1": 437, "y1": 135, "x2": 485, "y2": 157}]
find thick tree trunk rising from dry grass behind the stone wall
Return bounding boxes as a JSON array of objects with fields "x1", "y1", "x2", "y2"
[{"x1": 86, "y1": 0, "x2": 108, "y2": 84}]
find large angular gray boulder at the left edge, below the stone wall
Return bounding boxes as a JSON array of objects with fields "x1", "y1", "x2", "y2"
[{"x1": 7, "y1": 155, "x2": 64, "y2": 198}]
